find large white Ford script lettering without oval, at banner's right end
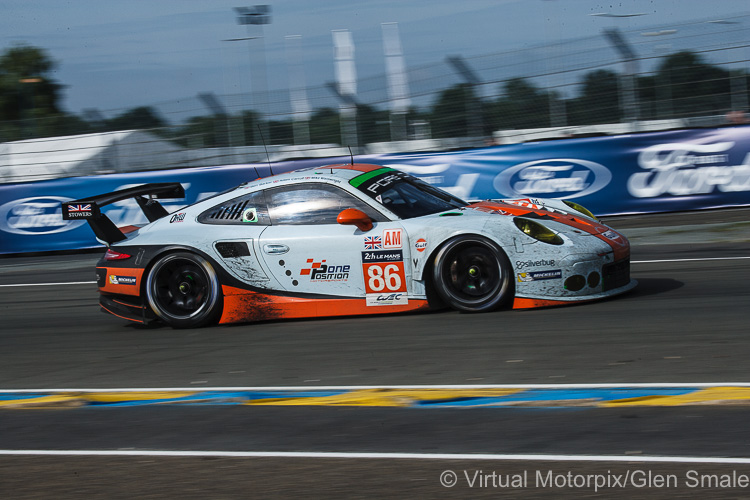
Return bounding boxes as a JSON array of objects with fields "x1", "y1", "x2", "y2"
[{"x1": 628, "y1": 141, "x2": 750, "y2": 198}]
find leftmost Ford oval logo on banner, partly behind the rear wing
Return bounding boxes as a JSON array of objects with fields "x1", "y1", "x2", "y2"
[{"x1": 0, "y1": 196, "x2": 84, "y2": 235}]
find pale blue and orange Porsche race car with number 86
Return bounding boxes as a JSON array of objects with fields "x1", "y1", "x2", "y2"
[{"x1": 62, "y1": 163, "x2": 636, "y2": 328}]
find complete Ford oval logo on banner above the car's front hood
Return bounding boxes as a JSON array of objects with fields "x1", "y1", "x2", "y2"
[{"x1": 493, "y1": 158, "x2": 612, "y2": 199}]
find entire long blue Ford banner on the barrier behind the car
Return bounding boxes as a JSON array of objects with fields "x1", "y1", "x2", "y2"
[{"x1": 0, "y1": 126, "x2": 750, "y2": 254}]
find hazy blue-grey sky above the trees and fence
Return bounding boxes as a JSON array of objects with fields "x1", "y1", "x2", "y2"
[{"x1": 0, "y1": 0, "x2": 750, "y2": 117}]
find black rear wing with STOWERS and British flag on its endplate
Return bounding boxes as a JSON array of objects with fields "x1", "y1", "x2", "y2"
[{"x1": 62, "y1": 182, "x2": 185, "y2": 245}]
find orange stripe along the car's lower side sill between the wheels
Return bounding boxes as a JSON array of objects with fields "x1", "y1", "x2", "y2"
[{"x1": 219, "y1": 285, "x2": 428, "y2": 323}]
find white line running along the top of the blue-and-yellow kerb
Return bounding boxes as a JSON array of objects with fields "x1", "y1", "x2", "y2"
[{"x1": 0, "y1": 382, "x2": 750, "y2": 394}]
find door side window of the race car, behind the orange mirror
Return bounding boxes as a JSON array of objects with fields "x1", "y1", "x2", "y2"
[{"x1": 266, "y1": 184, "x2": 388, "y2": 225}]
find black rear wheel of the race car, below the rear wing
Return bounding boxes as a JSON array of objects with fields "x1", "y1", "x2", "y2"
[{"x1": 146, "y1": 252, "x2": 223, "y2": 328}]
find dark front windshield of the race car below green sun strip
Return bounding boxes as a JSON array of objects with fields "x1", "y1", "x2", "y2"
[{"x1": 350, "y1": 167, "x2": 467, "y2": 219}]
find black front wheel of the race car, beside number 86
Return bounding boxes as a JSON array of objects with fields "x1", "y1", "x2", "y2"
[{"x1": 432, "y1": 235, "x2": 513, "y2": 312}]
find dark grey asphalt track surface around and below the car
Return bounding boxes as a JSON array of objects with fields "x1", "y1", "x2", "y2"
[{"x1": 0, "y1": 206, "x2": 750, "y2": 498}]
